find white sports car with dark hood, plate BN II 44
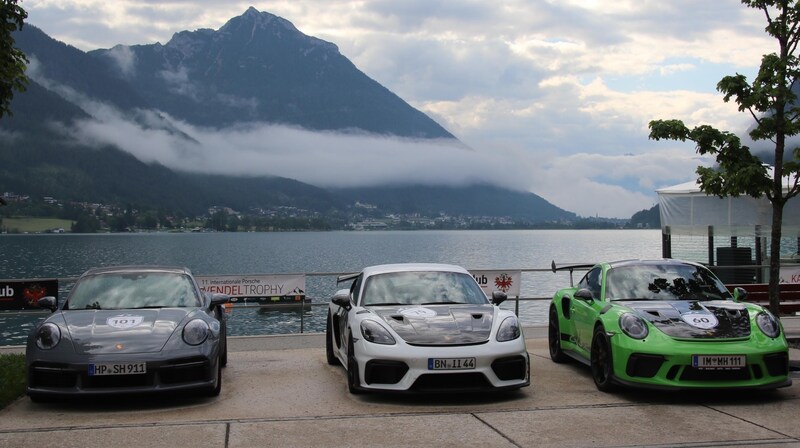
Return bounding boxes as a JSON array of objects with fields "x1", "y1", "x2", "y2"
[{"x1": 325, "y1": 263, "x2": 530, "y2": 393}]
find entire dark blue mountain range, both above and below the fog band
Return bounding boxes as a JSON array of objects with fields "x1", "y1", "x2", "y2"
[{"x1": 0, "y1": 8, "x2": 574, "y2": 222}]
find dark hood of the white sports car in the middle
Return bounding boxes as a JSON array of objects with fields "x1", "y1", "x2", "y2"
[{"x1": 371, "y1": 304, "x2": 494, "y2": 345}]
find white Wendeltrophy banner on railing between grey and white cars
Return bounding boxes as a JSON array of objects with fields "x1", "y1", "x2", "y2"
[{"x1": 195, "y1": 274, "x2": 306, "y2": 301}]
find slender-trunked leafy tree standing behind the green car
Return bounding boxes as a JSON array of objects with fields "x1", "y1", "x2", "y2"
[{"x1": 650, "y1": 0, "x2": 800, "y2": 315}]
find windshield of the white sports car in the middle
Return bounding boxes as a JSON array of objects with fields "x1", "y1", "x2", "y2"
[{"x1": 362, "y1": 271, "x2": 488, "y2": 306}]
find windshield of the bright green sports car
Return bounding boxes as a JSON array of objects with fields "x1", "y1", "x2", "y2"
[{"x1": 606, "y1": 264, "x2": 731, "y2": 300}]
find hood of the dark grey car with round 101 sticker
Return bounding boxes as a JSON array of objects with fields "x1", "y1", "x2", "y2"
[{"x1": 63, "y1": 308, "x2": 195, "y2": 354}]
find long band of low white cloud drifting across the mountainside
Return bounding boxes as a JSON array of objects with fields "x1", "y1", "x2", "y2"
[{"x1": 54, "y1": 96, "x2": 698, "y2": 218}]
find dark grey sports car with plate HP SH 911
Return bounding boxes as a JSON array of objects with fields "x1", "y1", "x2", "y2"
[{"x1": 26, "y1": 266, "x2": 229, "y2": 401}]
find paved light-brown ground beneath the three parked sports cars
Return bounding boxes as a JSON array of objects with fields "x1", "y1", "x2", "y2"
[{"x1": 0, "y1": 318, "x2": 800, "y2": 448}]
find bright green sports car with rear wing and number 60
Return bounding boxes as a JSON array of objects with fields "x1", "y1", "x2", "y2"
[{"x1": 548, "y1": 259, "x2": 792, "y2": 391}]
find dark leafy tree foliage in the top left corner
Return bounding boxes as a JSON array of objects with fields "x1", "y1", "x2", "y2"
[{"x1": 0, "y1": 0, "x2": 28, "y2": 118}]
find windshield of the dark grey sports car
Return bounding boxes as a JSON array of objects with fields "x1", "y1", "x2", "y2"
[{"x1": 64, "y1": 272, "x2": 200, "y2": 310}]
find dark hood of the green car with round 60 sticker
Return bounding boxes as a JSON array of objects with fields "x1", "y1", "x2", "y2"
[{"x1": 625, "y1": 300, "x2": 750, "y2": 339}]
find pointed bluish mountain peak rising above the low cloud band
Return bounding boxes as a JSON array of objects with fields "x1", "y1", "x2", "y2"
[{"x1": 88, "y1": 7, "x2": 453, "y2": 138}]
